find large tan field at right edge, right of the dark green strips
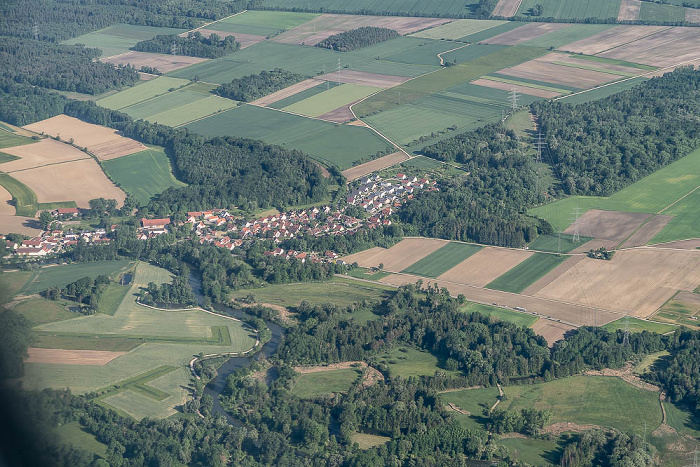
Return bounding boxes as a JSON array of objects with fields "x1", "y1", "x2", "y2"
[{"x1": 537, "y1": 248, "x2": 700, "y2": 317}]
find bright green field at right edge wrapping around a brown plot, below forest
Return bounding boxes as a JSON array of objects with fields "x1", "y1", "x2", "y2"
[{"x1": 529, "y1": 149, "x2": 700, "y2": 243}]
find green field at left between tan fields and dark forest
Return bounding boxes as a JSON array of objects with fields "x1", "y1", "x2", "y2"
[{"x1": 102, "y1": 148, "x2": 185, "y2": 206}]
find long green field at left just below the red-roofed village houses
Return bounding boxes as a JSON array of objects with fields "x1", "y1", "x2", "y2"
[{"x1": 19, "y1": 260, "x2": 130, "y2": 295}]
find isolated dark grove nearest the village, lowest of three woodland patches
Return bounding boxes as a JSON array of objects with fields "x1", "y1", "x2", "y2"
[{"x1": 214, "y1": 68, "x2": 306, "y2": 102}]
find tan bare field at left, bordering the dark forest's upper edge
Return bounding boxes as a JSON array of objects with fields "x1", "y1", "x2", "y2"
[{"x1": 25, "y1": 115, "x2": 148, "y2": 161}]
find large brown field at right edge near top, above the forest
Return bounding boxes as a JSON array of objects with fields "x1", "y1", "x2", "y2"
[{"x1": 598, "y1": 28, "x2": 700, "y2": 67}]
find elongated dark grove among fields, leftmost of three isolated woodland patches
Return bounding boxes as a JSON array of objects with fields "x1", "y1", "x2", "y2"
[{"x1": 131, "y1": 31, "x2": 241, "y2": 58}]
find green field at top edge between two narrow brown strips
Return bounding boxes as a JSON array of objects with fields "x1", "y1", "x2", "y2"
[{"x1": 516, "y1": 0, "x2": 620, "y2": 21}]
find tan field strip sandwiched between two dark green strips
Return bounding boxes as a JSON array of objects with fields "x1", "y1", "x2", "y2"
[{"x1": 438, "y1": 247, "x2": 532, "y2": 287}]
